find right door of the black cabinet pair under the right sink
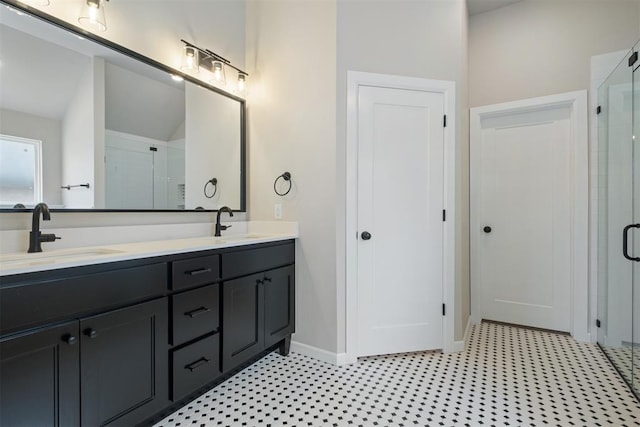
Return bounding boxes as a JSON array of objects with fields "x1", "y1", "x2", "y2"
[{"x1": 264, "y1": 266, "x2": 296, "y2": 347}]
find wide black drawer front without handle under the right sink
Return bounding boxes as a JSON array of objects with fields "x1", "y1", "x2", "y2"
[{"x1": 222, "y1": 242, "x2": 296, "y2": 279}]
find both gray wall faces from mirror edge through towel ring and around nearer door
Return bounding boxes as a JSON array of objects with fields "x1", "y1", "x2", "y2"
[{"x1": 246, "y1": 0, "x2": 469, "y2": 353}]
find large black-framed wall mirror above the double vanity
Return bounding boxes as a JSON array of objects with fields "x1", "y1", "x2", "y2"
[{"x1": 0, "y1": 1, "x2": 245, "y2": 211}]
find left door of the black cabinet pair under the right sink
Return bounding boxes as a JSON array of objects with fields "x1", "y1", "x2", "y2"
[{"x1": 222, "y1": 274, "x2": 264, "y2": 371}]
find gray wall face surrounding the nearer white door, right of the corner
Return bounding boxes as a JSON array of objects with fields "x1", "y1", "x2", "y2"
[{"x1": 336, "y1": 0, "x2": 469, "y2": 346}]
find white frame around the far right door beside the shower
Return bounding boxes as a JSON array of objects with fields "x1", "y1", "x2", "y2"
[{"x1": 469, "y1": 90, "x2": 590, "y2": 342}]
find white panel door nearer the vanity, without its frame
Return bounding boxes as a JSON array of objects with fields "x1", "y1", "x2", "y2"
[{"x1": 357, "y1": 86, "x2": 444, "y2": 356}]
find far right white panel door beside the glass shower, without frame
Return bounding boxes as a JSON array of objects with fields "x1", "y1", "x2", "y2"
[{"x1": 471, "y1": 107, "x2": 573, "y2": 331}]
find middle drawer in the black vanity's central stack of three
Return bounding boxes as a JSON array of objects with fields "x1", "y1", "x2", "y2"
[{"x1": 171, "y1": 283, "x2": 220, "y2": 345}]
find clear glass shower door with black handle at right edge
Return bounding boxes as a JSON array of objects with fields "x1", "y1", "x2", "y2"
[{"x1": 598, "y1": 46, "x2": 640, "y2": 392}]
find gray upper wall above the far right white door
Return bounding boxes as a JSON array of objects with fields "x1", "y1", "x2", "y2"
[{"x1": 469, "y1": 0, "x2": 640, "y2": 107}]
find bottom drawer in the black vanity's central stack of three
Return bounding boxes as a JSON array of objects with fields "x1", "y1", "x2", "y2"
[{"x1": 171, "y1": 334, "x2": 220, "y2": 401}]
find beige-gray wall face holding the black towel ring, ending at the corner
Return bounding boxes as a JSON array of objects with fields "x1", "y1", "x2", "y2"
[{"x1": 246, "y1": 0, "x2": 339, "y2": 352}]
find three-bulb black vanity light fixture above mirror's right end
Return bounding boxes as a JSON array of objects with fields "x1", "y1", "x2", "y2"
[{"x1": 181, "y1": 40, "x2": 249, "y2": 93}]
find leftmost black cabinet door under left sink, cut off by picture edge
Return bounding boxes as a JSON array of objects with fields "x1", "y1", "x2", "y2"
[{"x1": 0, "y1": 321, "x2": 80, "y2": 427}]
